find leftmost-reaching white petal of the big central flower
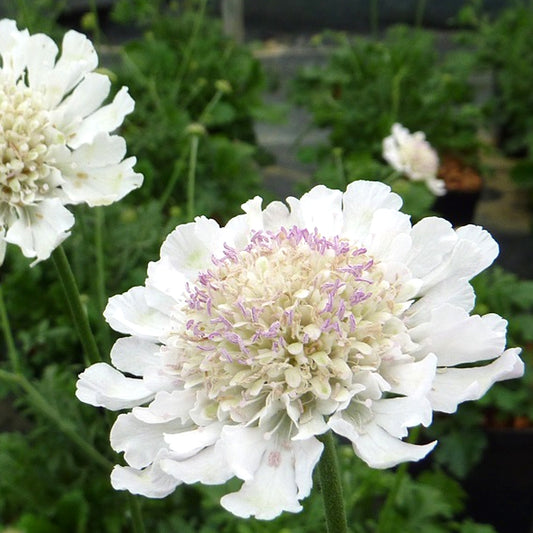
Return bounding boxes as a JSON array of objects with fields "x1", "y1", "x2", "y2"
[{"x1": 76, "y1": 363, "x2": 154, "y2": 411}]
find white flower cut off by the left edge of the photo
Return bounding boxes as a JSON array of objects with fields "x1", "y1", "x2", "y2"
[{"x1": 0, "y1": 19, "x2": 142, "y2": 264}]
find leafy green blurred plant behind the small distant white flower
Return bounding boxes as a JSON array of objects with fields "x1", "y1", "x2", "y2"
[{"x1": 292, "y1": 26, "x2": 479, "y2": 218}]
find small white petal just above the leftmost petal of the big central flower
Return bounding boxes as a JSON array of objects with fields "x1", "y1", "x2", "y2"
[{"x1": 111, "y1": 337, "x2": 160, "y2": 377}]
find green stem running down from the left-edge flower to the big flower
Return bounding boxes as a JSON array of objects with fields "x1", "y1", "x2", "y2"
[{"x1": 52, "y1": 246, "x2": 101, "y2": 366}]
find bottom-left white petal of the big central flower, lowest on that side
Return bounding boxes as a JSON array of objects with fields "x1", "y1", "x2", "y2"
[{"x1": 111, "y1": 453, "x2": 180, "y2": 498}]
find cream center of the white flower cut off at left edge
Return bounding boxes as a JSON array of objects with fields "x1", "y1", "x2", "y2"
[{"x1": 0, "y1": 81, "x2": 53, "y2": 206}]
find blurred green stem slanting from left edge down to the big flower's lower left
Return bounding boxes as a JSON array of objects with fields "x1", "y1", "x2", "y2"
[{"x1": 0, "y1": 369, "x2": 113, "y2": 472}]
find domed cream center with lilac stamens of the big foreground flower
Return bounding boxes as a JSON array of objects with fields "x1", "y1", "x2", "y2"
[{"x1": 166, "y1": 227, "x2": 406, "y2": 422}]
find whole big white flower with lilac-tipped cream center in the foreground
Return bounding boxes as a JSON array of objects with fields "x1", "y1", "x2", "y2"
[{"x1": 77, "y1": 181, "x2": 523, "y2": 519}]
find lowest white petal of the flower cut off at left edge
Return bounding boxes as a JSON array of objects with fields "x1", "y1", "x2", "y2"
[{"x1": 5, "y1": 198, "x2": 74, "y2": 265}]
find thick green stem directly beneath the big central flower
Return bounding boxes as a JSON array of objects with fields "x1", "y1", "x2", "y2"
[{"x1": 318, "y1": 431, "x2": 348, "y2": 533}]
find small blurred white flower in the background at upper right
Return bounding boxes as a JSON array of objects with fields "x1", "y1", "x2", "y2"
[{"x1": 383, "y1": 124, "x2": 446, "y2": 196}]
